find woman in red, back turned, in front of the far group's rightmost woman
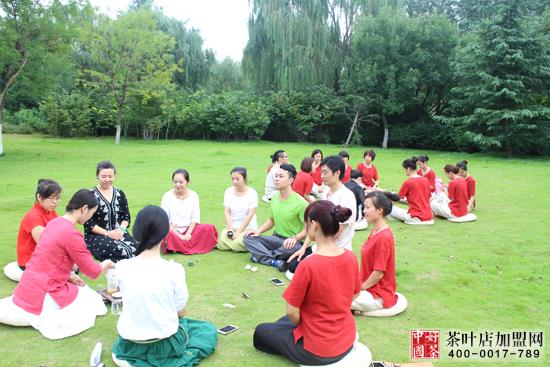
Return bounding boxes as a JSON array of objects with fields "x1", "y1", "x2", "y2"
[{"x1": 430, "y1": 164, "x2": 468, "y2": 219}]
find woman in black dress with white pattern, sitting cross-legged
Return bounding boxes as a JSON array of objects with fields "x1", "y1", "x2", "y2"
[{"x1": 84, "y1": 161, "x2": 136, "y2": 262}]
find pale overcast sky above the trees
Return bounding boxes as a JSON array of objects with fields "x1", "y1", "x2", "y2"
[{"x1": 90, "y1": 0, "x2": 252, "y2": 61}]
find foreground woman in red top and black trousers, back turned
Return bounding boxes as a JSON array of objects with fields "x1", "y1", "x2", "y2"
[{"x1": 254, "y1": 200, "x2": 360, "y2": 365}]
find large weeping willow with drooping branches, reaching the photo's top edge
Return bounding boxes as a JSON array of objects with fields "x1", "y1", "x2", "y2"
[{"x1": 243, "y1": 0, "x2": 338, "y2": 91}]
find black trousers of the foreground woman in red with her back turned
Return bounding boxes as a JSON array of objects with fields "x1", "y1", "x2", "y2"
[{"x1": 254, "y1": 316, "x2": 351, "y2": 366}]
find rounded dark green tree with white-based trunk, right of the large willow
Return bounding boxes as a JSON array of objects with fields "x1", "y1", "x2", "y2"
[{"x1": 346, "y1": 8, "x2": 456, "y2": 148}]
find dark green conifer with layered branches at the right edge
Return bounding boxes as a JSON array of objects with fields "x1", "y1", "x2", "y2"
[{"x1": 441, "y1": 0, "x2": 550, "y2": 157}]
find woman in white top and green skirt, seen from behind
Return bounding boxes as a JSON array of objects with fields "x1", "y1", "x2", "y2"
[{"x1": 113, "y1": 206, "x2": 217, "y2": 366}]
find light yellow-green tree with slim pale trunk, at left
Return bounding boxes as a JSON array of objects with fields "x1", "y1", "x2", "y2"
[{"x1": 78, "y1": 8, "x2": 175, "y2": 144}]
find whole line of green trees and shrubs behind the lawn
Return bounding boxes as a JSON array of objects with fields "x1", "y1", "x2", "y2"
[{"x1": 0, "y1": 0, "x2": 550, "y2": 157}]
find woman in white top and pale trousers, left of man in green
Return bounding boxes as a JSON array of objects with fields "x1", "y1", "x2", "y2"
[{"x1": 216, "y1": 167, "x2": 258, "y2": 252}]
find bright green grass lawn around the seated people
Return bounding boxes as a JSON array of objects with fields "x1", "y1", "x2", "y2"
[{"x1": 0, "y1": 135, "x2": 550, "y2": 367}]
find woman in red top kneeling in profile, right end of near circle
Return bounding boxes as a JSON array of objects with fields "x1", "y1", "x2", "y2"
[{"x1": 351, "y1": 191, "x2": 397, "y2": 312}]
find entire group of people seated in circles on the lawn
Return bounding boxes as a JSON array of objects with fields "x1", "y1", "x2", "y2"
[{"x1": 0, "y1": 150, "x2": 475, "y2": 366}]
